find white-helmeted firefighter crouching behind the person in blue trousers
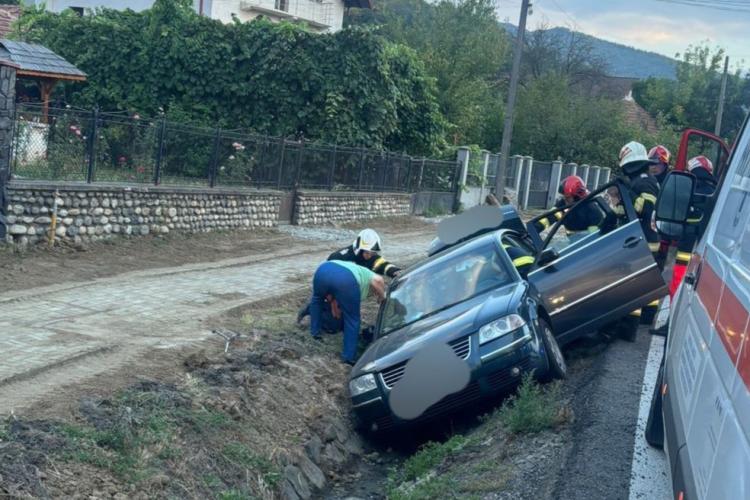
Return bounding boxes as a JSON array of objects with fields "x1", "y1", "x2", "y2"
[{"x1": 297, "y1": 229, "x2": 401, "y2": 326}]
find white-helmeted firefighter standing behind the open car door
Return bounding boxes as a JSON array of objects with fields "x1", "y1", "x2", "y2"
[{"x1": 620, "y1": 141, "x2": 659, "y2": 340}]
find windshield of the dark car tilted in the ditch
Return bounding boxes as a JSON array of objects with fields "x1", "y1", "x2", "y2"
[{"x1": 380, "y1": 241, "x2": 512, "y2": 335}]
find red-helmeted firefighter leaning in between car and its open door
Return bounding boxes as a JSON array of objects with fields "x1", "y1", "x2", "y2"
[{"x1": 534, "y1": 175, "x2": 605, "y2": 241}]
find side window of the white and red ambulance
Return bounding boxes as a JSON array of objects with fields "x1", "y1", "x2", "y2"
[{"x1": 714, "y1": 148, "x2": 750, "y2": 258}]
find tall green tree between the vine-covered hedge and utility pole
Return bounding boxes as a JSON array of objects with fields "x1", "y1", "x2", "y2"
[{"x1": 347, "y1": 0, "x2": 509, "y2": 148}]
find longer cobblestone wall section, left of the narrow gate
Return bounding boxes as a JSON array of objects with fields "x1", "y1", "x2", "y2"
[{"x1": 6, "y1": 181, "x2": 281, "y2": 245}]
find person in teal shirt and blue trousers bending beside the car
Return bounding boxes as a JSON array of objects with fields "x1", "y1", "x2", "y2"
[{"x1": 310, "y1": 260, "x2": 385, "y2": 365}]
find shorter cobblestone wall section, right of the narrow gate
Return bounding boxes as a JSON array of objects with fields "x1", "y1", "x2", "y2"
[{"x1": 294, "y1": 191, "x2": 412, "y2": 225}]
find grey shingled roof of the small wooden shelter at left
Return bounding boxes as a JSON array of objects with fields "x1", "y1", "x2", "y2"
[{"x1": 0, "y1": 38, "x2": 86, "y2": 80}]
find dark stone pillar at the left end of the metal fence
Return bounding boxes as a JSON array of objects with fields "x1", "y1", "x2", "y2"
[{"x1": 0, "y1": 63, "x2": 16, "y2": 242}]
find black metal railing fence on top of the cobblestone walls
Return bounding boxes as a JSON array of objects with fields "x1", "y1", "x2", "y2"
[{"x1": 11, "y1": 104, "x2": 460, "y2": 192}]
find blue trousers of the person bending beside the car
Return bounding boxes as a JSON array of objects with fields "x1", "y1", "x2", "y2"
[{"x1": 310, "y1": 262, "x2": 360, "y2": 362}]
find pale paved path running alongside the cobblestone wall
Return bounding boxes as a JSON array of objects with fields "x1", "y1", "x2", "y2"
[{"x1": 0, "y1": 223, "x2": 434, "y2": 414}]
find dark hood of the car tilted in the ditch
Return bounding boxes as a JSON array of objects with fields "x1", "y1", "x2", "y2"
[{"x1": 351, "y1": 281, "x2": 528, "y2": 378}]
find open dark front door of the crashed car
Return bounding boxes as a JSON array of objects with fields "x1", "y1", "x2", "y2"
[{"x1": 528, "y1": 181, "x2": 667, "y2": 343}]
